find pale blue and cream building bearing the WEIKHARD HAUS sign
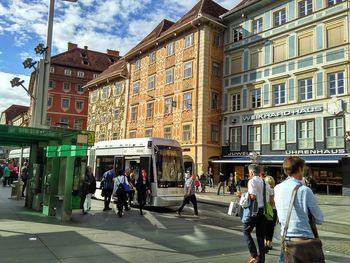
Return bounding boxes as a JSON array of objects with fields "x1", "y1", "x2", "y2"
[{"x1": 218, "y1": 0, "x2": 350, "y2": 195}]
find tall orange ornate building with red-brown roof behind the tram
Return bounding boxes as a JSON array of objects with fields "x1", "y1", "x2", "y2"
[{"x1": 125, "y1": 0, "x2": 227, "y2": 178}]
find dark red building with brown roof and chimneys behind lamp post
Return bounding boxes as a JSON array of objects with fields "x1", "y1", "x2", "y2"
[{"x1": 47, "y1": 43, "x2": 119, "y2": 130}]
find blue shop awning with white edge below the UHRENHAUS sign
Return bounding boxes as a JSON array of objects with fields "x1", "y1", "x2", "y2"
[{"x1": 213, "y1": 154, "x2": 347, "y2": 164}]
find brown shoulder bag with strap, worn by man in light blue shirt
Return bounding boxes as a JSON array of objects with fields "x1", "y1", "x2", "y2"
[{"x1": 282, "y1": 185, "x2": 325, "y2": 263}]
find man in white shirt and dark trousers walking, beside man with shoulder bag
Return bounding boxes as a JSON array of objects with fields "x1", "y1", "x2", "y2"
[{"x1": 243, "y1": 164, "x2": 265, "y2": 263}]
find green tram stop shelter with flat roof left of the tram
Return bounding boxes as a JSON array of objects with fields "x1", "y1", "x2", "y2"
[{"x1": 0, "y1": 125, "x2": 94, "y2": 221}]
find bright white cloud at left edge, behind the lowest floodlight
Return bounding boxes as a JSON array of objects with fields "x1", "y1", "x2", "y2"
[{"x1": 0, "y1": 72, "x2": 30, "y2": 112}]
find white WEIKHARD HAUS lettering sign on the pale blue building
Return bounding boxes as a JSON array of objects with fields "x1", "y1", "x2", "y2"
[{"x1": 242, "y1": 106, "x2": 323, "y2": 122}]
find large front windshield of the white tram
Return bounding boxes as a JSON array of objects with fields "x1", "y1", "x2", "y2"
[{"x1": 156, "y1": 145, "x2": 184, "y2": 187}]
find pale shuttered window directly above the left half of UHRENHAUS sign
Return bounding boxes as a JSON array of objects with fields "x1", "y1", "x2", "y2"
[{"x1": 297, "y1": 120, "x2": 315, "y2": 150}]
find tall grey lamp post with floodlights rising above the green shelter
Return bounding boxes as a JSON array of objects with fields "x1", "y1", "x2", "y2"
[{"x1": 31, "y1": 0, "x2": 77, "y2": 127}]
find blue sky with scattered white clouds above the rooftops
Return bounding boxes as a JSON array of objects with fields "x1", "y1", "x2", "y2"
[{"x1": 0, "y1": 0, "x2": 241, "y2": 113}]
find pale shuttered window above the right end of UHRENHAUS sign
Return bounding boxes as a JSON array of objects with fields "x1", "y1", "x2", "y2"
[{"x1": 326, "y1": 117, "x2": 344, "y2": 148}]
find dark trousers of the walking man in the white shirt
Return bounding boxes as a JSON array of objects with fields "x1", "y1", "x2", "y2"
[{"x1": 243, "y1": 208, "x2": 266, "y2": 263}]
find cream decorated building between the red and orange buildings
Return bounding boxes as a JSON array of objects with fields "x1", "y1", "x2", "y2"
[{"x1": 84, "y1": 59, "x2": 129, "y2": 142}]
